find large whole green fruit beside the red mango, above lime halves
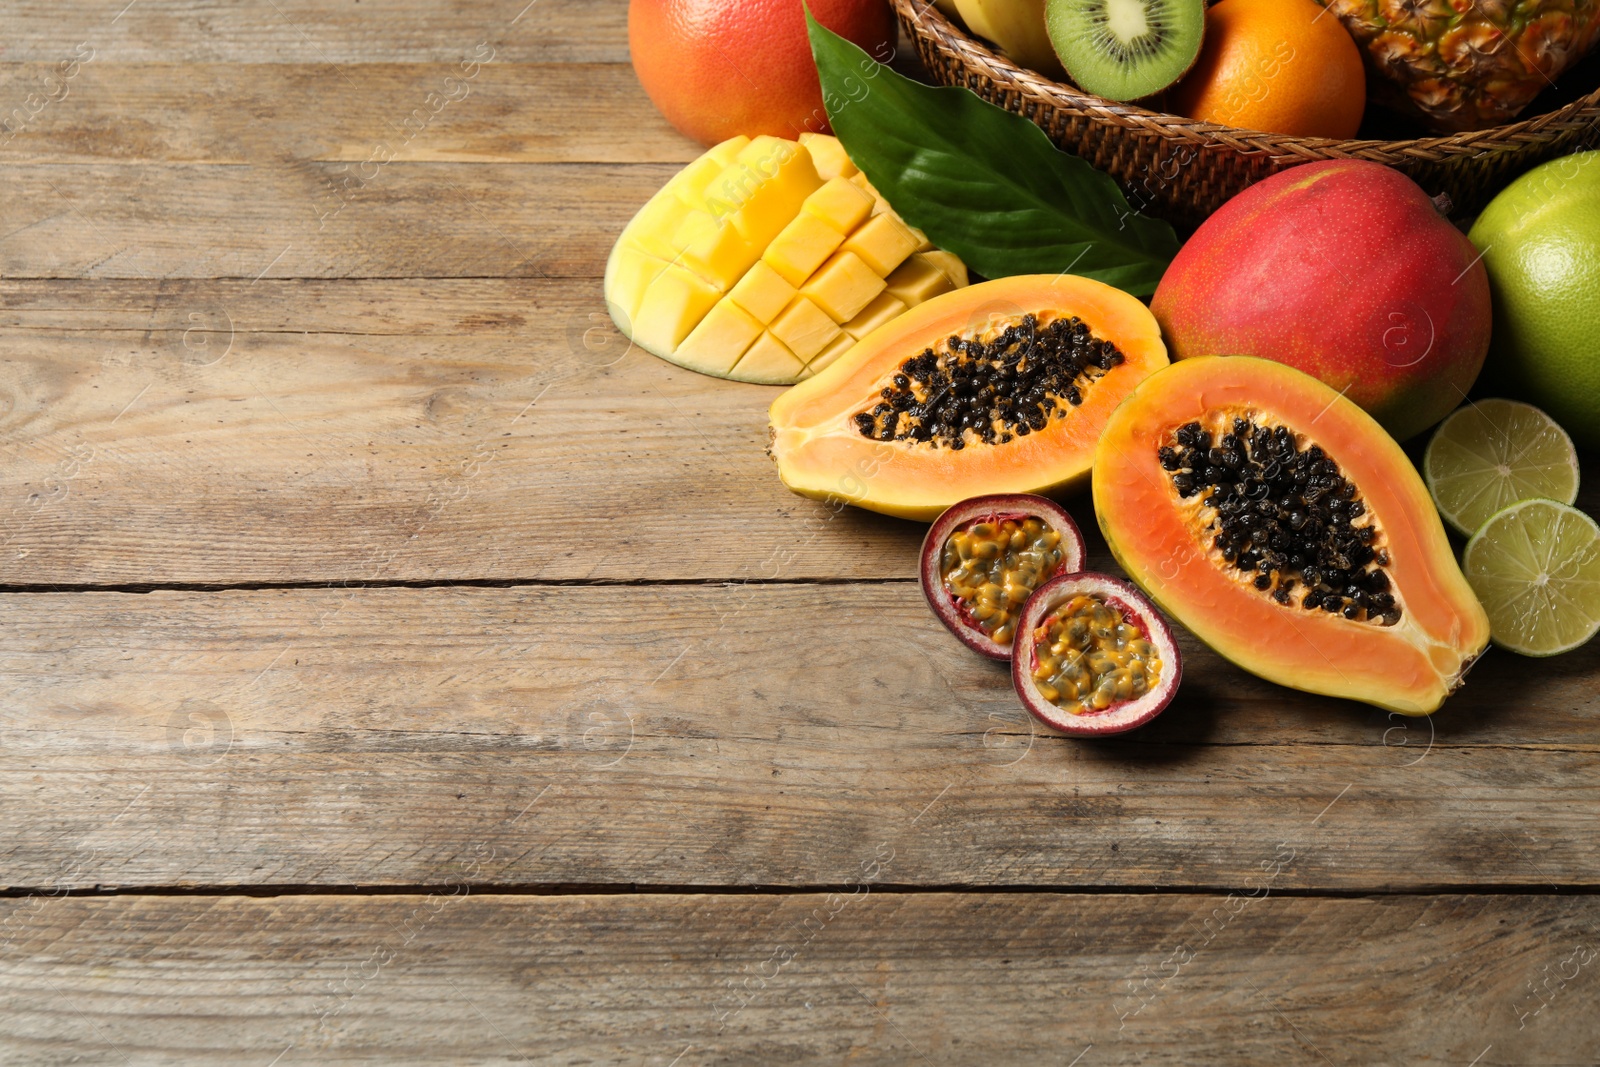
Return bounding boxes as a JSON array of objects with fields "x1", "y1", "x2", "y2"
[{"x1": 1467, "y1": 152, "x2": 1600, "y2": 448}]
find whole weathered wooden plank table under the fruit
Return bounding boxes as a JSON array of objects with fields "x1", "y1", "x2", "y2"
[{"x1": 0, "y1": 0, "x2": 1600, "y2": 1067}]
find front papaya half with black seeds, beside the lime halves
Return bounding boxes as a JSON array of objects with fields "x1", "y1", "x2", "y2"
[{"x1": 1094, "y1": 355, "x2": 1490, "y2": 715}]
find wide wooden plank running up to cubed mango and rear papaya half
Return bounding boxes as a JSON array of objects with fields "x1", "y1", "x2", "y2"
[{"x1": 0, "y1": 280, "x2": 922, "y2": 584}]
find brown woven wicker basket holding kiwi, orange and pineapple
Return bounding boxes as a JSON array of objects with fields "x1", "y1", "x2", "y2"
[{"x1": 893, "y1": 0, "x2": 1600, "y2": 229}]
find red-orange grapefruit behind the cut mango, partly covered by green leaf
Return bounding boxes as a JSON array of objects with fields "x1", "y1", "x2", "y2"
[{"x1": 627, "y1": 0, "x2": 902, "y2": 146}]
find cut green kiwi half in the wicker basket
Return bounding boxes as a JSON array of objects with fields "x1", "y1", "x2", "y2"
[{"x1": 1045, "y1": 0, "x2": 1205, "y2": 101}]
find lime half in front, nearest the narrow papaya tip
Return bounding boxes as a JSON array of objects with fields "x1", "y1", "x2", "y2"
[{"x1": 1461, "y1": 501, "x2": 1600, "y2": 656}]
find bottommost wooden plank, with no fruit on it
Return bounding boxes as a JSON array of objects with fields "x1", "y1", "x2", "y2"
[{"x1": 0, "y1": 895, "x2": 1600, "y2": 1067}]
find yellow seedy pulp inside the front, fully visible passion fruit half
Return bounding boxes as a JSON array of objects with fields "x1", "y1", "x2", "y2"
[{"x1": 1034, "y1": 593, "x2": 1162, "y2": 715}]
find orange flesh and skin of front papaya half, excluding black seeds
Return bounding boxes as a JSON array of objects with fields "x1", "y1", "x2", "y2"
[{"x1": 1094, "y1": 355, "x2": 1490, "y2": 715}]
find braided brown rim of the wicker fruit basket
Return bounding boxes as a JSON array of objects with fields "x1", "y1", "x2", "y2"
[{"x1": 893, "y1": 0, "x2": 1600, "y2": 163}]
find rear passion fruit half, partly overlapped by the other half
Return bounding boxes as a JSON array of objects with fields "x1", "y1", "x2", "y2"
[{"x1": 922, "y1": 493, "x2": 1083, "y2": 659}]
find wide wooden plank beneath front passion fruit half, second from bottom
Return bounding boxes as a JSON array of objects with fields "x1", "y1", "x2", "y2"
[{"x1": 0, "y1": 584, "x2": 1600, "y2": 891}]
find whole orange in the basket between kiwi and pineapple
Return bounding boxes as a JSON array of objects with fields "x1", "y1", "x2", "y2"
[{"x1": 1170, "y1": 0, "x2": 1366, "y2": 139}]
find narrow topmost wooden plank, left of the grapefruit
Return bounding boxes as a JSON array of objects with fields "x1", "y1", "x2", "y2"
[{"x1": 5, "y1": 0, "x2": 627, "y2": 63}]
